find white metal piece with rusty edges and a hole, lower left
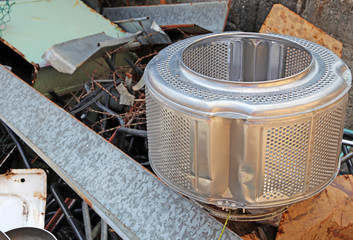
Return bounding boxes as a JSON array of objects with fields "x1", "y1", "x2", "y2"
[{"x1": 0, "y1": 169, "x2": 47, "y2": 232}]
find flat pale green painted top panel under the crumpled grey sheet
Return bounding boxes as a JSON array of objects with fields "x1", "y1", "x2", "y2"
[{"x1": 0, "y1": 0, "x2": 125, "y2": 65}]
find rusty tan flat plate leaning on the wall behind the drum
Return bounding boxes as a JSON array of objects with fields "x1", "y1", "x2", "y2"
[{"x1": 260, "y1": 4, "x2": 343, "y2": 57}]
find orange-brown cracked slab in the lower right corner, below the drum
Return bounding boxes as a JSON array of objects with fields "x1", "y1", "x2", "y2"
[{"x1": 276, "y1": 175, "x2": 353, "y2": 240}]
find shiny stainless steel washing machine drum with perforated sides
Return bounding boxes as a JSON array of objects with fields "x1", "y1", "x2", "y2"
[{"x1": 144, "y1": 32, "x2": 352, "y2": 208}]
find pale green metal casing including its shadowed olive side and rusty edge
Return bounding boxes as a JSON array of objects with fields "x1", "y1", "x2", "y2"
[{"x1": 0, "y1": 0, "x2": 126, "y2": 95}]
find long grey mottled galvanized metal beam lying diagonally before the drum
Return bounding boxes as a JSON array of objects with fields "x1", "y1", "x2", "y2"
[{"x1": 0, "y1": 66, "x2": 241, "y2": 239}]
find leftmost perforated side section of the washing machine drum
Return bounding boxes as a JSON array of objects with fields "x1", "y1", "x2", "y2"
[{"x1": 147, "y1": 94, "x2": 191, "y2": 189}]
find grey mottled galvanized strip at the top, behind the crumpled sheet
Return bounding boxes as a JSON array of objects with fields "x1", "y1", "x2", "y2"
[{"x1": 103, "y1": 1, "x2": 230, "y2": 33}]
